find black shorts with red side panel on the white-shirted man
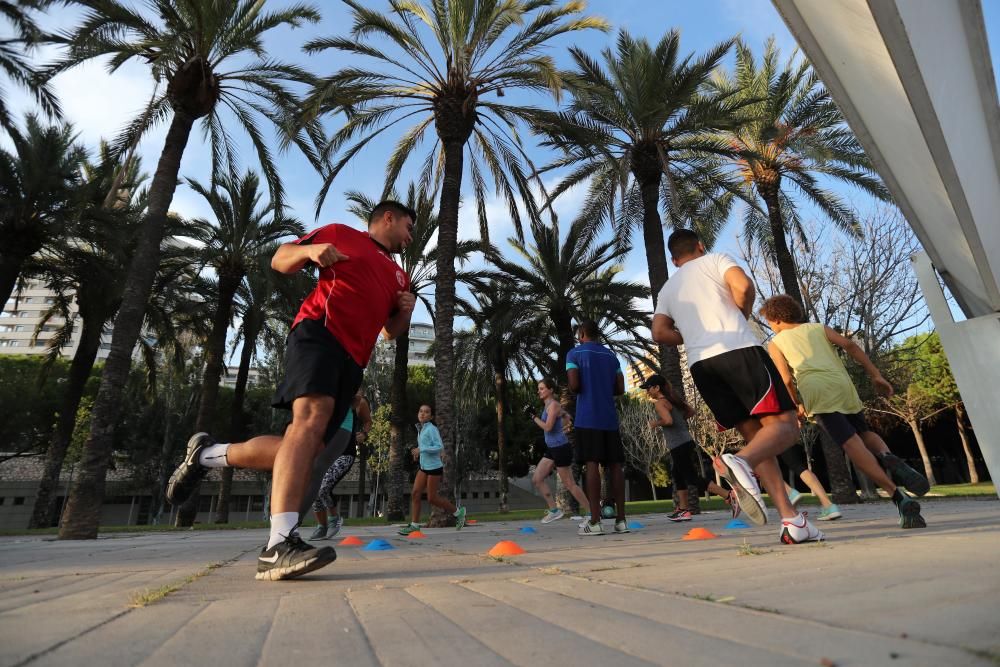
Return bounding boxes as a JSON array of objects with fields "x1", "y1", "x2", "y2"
[{"x1": 691, "y1": 345, "x2": 795, "y2": 431}]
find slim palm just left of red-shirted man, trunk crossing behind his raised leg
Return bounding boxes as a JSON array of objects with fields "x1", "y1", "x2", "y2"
[{"x1": 215, "y1": 248, "x2": 313, "y2": 523}]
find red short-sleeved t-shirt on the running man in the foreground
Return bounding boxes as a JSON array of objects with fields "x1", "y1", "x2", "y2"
[{"x1": 292, "y1": 224, "x2": 410, "y2": 368}]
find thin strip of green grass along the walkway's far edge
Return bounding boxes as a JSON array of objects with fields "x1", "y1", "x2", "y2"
[{"x1": 0, "y1": 482, "x2": 996, "y2": 536}]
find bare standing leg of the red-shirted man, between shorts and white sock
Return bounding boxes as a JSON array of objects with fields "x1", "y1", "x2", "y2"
[{"x1": 271, "y1": 394, "x2": 334, "y2": 514}]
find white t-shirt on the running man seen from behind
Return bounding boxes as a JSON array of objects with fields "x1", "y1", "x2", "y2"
[{"x1": 656, "y1": 253, "x2": 760, "y2": 366}]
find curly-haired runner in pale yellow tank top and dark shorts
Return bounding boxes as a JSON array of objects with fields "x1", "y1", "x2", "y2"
[{"x1": 760, "y1": 294, "x2": 930, "y2": 528}]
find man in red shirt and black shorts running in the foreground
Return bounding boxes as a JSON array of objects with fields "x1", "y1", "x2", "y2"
[{"x1": 166, "y1": 201, "x2": 416, "y2": 581}]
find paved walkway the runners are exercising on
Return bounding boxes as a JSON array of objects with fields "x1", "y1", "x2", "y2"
[{"x1": 0, "y1": 499, "x2": 1000, "y2": 667}]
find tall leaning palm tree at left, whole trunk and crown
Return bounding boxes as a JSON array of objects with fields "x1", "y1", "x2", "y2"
[{"x1": 51, "y1": 0, "x2": 319, "y2": 539}]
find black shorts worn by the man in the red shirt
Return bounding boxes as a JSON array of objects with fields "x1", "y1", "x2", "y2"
[{"x1": 271, "y1": 320, "x2": 364, "y2": 440}]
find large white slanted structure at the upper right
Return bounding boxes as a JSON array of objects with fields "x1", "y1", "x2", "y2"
[{"x1": 773, "y1": 0, "x2": 1000, "y2": 490}]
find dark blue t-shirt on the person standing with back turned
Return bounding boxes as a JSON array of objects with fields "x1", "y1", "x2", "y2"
[{"x1": 566, "y1": 342, "x2": 622, "y2": 431}]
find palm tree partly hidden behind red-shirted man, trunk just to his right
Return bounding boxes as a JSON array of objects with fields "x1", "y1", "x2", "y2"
[{"x1": 346, "y1": 183, "x2": 480, "y2": 521}]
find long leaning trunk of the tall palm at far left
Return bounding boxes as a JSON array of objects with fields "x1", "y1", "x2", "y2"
[{"x1": 59, "y1": 111, "x2": 195, "y2": 540}]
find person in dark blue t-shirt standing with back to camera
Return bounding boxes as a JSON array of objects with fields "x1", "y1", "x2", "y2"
[{"x1": 566, "y1": 320, "x2": 629, "y2": 535}]
